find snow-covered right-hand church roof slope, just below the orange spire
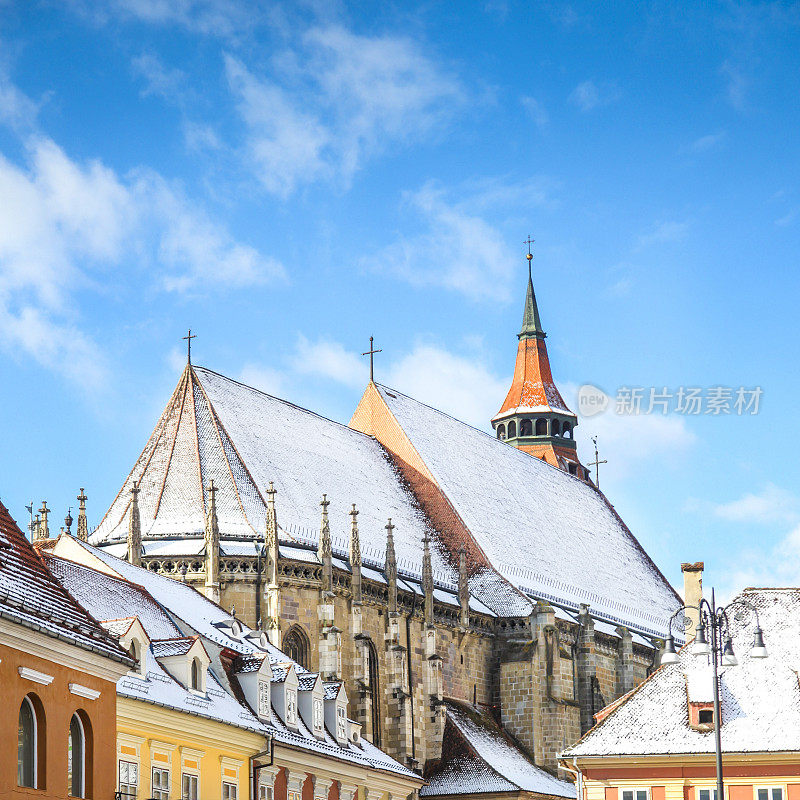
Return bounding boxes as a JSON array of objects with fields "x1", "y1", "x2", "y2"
[{"x1": 377, "y1": 385, "x2": 680, "y2": 635}]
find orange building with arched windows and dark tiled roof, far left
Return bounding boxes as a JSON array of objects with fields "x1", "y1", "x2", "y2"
[{"x1": 0, "y1": 504, "x2": 133, "y2": 800}]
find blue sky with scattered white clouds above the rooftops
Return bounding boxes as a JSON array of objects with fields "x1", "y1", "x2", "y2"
[{"x1": 0, "y1": 0, "x2": 800, "y2": 591}]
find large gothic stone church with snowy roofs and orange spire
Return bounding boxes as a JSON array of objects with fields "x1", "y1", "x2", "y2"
[{"x1": 72, "y1": 262, "x2": 681, "y2": 797}]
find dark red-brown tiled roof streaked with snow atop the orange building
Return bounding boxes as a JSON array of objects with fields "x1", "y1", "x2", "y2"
[{"x1": 0, "y1": 503, "x2": 133, "y2": 664}]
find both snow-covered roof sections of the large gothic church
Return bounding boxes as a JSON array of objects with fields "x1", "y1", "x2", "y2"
[{"x1": 90, "y1": 366, "x2": 678, "y2": 635}]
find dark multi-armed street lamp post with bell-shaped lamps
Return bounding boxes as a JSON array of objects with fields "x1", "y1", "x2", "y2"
[{"x1": 661, "y1": 589, "x2": 767, "y2": 800}]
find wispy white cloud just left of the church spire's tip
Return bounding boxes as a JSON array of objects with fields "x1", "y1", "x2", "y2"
[{"x1": 362, "y1": 183, "x2": 546, "y2": 301}]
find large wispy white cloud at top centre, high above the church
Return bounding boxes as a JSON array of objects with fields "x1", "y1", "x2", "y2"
[{"x1": 225, "y1": 25, "x2": 462, "y2": 197}]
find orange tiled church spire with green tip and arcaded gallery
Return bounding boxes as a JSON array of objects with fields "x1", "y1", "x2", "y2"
[{"x1": 492, "y1": 250, "x2": 586, "y2": 477}]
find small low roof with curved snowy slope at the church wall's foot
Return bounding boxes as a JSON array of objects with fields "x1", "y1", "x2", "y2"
[{"x1": 420, "y1": 700, "x2": 575, "y2": 798}]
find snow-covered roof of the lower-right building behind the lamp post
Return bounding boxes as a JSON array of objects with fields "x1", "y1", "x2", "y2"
[{"x1": 563, "y1": 589, "x2": 800, "y2": 758}]
